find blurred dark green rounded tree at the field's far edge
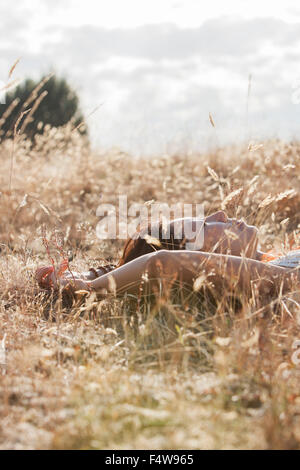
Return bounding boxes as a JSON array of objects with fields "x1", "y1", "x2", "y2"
[{"x1": 0, "y1": 75, "x2": 87, "y2": 139}]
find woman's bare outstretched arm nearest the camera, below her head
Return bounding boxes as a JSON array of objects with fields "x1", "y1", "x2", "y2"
[{"x1": 75, "y1": 250, "x2": 300, "y2": 295}]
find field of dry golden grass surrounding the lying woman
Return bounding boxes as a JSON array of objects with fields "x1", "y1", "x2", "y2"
[{"x1": 0, "y1": 126, "x2": 300, "y2": 449}]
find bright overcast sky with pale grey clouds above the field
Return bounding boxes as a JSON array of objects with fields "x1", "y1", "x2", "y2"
[{"x1": 0, "y1": 0, "x2": 300, "y2": 155}]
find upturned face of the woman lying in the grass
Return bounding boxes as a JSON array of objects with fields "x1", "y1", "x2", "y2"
[{"x1": 201, "y1": 211, "x2": 258, "y2": 258}]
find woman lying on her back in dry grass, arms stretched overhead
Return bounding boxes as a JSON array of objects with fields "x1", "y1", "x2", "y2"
[{"x1": 36, "y1": 211, "x2": 300, "y2": 302}]
